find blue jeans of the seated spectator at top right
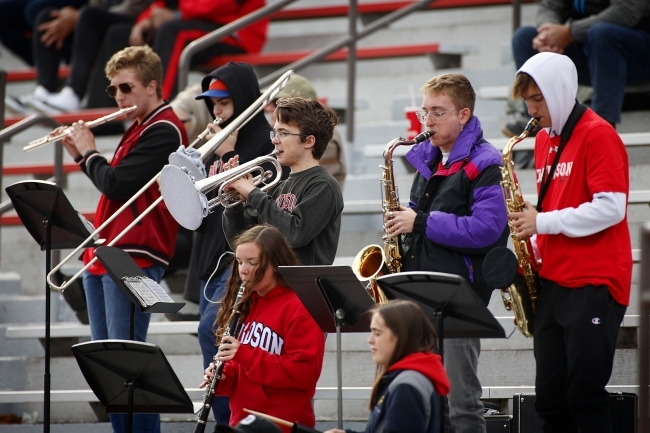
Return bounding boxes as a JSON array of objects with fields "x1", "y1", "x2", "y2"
[{"x1": 512, "y1": 23, "x2": 650, "y2": 123}]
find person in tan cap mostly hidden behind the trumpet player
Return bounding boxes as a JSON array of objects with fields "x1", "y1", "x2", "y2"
[{"x1": 264, "y1": 74, "x2": 347, "y2": 191}]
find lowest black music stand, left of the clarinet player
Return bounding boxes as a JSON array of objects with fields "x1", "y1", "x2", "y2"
[{"x1": 72, "y1": 340, "x2": 194, "y2": 433}]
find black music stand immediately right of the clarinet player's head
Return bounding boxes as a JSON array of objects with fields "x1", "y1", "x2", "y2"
[{"x1": 278, "y1": 266, "x2": 374, "y2": 429}]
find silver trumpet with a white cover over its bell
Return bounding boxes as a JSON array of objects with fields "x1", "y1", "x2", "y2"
[{"x1": 160, "y1": 150, "x2": 282, "y2": 230}]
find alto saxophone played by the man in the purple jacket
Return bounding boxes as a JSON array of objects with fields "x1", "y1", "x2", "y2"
[{"x1": 352, "y1": 131, "x2": 432, "y2": 304}]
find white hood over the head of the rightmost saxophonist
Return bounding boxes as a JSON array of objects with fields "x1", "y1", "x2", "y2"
[{"x1": 517, "y1": 53, "x2": 578, "y2": 137}]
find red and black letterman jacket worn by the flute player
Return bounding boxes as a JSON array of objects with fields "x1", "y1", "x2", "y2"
[{"x1": 77, "y1": 103, "x2": 188, "y2": 274}]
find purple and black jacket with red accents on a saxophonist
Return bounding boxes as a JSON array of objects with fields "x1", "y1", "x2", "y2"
[{"x1": 404, "y1": 117, "x2": 509, "y2": 305}]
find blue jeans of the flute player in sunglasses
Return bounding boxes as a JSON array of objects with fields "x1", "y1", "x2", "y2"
[{"x1": 83, "y1": 265, "x2": 165, "y2": 433}]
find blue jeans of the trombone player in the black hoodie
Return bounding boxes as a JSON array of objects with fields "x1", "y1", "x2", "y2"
[{"x1": 199, "y1": 266, "x2": 231, "y2": 424}]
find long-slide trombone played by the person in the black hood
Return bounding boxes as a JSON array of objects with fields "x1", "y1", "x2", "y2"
[{"x1": 46, "y1": 70, "x2": 293, "y2": 292}]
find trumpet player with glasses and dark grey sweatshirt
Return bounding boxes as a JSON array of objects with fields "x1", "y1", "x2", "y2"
[{"x1": 223, "y1": 97, "x2": 343, "y2": 265}]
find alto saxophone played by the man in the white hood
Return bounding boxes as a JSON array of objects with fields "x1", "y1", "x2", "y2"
[{"x1": 501, "y1": 118, "x2": 541, "y2": 337}]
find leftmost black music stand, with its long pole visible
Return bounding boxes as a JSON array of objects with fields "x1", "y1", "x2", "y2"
[{"x1": 5, "y1": 180, "x2": 94, "y2": 433}]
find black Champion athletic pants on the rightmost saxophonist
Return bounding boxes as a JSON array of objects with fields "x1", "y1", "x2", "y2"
[{"x1": 533, "y1": 280, "x2": 627, "y2": 433}]
